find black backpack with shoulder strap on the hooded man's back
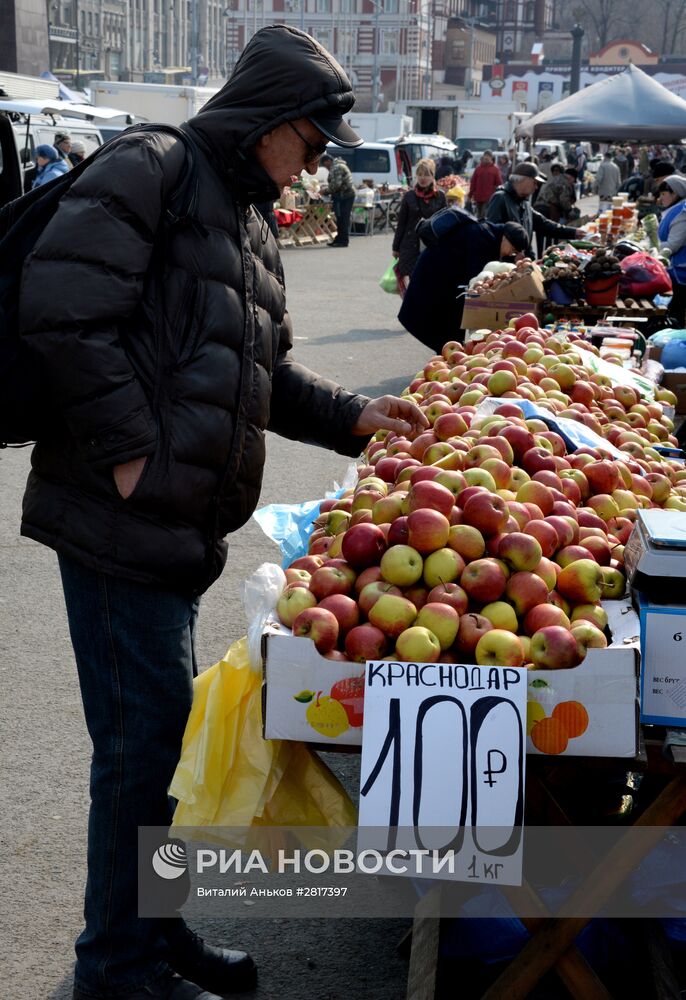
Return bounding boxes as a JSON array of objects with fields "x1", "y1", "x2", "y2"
[{"x1": 0, "y1": 125, "x2": 198, "y2": 448}]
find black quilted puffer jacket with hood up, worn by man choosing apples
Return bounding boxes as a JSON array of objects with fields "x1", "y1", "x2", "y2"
[{"x1": 20, "y1": 26, "x2": 368, "y2": 594}]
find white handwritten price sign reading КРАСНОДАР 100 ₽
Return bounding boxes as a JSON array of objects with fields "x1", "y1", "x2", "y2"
[{"x1": 358, "y1": 661, "x2": 526, "y2": 885}]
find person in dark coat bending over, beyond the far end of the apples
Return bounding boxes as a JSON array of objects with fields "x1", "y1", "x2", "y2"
[{"x1": 398, "y1": 208, "x2": 529, "y2": 353}]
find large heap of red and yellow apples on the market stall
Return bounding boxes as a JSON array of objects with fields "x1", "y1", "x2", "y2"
[{"x1": 277, "y1": 316, "x2": 686, "y2": 669}]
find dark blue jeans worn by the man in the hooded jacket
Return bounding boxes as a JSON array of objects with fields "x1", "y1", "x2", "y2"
[{"x1": 59, "y1": 556, "x2": 198, "y2": 997}]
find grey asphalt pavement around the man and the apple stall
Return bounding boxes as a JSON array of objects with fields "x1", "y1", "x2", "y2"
[{"x1": 0, "y1": 235, "x2": 436, "y2": 1000}]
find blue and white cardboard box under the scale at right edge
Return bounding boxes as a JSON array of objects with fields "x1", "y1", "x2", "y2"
[{"x1": 637, "y1": 592, "x2": 686, "y2": 726}]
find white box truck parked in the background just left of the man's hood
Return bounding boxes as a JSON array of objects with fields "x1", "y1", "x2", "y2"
[{"x1": 91, "y1": 80, "x2": 217, "y2": 125}]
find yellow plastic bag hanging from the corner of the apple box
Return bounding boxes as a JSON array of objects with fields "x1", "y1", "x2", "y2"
[{"x1": 169, "y1": 637, "x2": 357, "y2": 835}]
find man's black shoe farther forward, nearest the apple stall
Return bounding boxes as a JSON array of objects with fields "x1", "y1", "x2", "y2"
[{"x1": 167, "y1": 927, "x2": 257, "y2": 1000}]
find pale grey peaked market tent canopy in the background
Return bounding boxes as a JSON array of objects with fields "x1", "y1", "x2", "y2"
[{"x1": 516, "y1": 65, "x2": 686, "y2": 142}]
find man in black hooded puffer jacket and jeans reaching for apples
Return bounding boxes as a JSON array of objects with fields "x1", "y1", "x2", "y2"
[{"x1": 20, "y1": 26, "x2": 428, "y2": 1000}]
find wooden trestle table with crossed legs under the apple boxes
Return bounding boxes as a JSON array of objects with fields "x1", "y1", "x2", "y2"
[{"x1": 407, "y1": 739, "x2": 686, "y2": 1000}]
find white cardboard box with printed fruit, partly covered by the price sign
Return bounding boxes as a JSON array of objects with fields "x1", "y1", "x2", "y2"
[{"x1": 262, "y1": 601, "x2": 644, "y2": 757}]
